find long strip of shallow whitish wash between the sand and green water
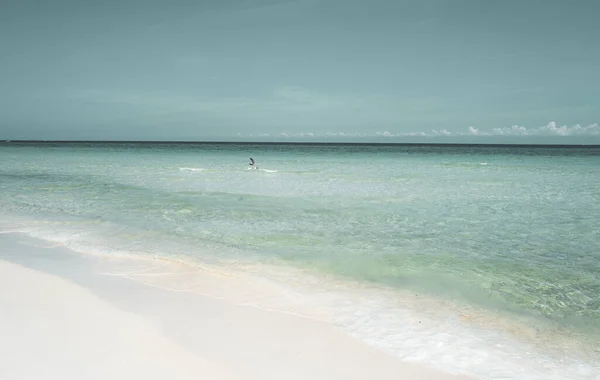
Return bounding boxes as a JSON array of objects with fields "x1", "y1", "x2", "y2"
[{"x1": 0, "y1": 225, "x2": 600, "y2": 380}]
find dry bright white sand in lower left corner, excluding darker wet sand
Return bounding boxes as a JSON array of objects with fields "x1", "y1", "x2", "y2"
[{"x1": 0, "y1": 261, "x2": 235, "y2": 380}]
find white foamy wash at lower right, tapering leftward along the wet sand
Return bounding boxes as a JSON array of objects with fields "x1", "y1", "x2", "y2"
[{"x1": 230, "y1": 265, "x2": 600, "y2": 380}]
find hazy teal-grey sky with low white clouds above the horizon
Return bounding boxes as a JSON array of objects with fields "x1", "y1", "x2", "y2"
[{"x1": 0, "y1": 0, "x2": 600, "y2": 144}]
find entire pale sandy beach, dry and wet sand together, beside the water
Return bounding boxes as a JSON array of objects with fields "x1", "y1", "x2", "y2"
[{"x1": 0, "y1": 235, "x2": 476, "y2": 380}]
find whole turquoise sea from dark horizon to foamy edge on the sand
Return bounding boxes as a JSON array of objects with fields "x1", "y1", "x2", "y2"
[{"x1": 0, "y1": 142, "x2": 600, "y2": 379}]
